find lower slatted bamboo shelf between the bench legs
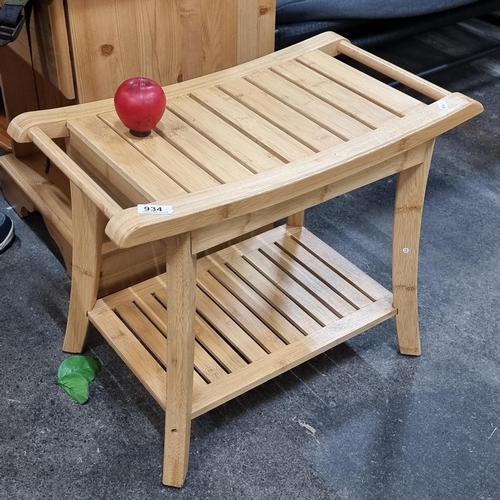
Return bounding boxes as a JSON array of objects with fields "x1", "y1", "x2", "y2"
[{"x1": 89, "y1": 226, "x2": 396, "y2": 417}]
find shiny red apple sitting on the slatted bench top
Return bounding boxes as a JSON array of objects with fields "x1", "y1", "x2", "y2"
[{"x1": 114, "y1": 77, "x2": 167, "y2": 137}]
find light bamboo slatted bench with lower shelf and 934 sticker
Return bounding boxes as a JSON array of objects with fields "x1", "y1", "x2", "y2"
[{"x1": 6, "y1": 33, "x2": 482, "y2": 487}]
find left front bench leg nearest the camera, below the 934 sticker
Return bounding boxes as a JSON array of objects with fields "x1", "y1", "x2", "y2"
[{"x1": 163, "y1": 233, "x2": 196, "y2": 488}]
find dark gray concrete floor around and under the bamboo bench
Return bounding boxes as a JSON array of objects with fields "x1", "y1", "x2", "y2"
[{"x1": 0, "y1": 22, "x2": 500, "y2": 500}]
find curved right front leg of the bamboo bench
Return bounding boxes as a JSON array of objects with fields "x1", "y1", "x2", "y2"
[{"x1": 392, "y1": 140, "x2": 434, "y2": 356}]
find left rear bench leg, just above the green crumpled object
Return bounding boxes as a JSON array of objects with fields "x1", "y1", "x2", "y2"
[{"x1": 63, "y1": 184, "x2": 106, "y2": 353}]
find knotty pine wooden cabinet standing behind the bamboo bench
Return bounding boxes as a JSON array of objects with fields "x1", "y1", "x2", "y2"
[{"x1": 0, "y1": 0, "x2": 276, "y2": 288}]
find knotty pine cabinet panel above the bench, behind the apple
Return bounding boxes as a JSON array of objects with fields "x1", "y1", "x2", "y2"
[{"x1": 67, "y1": 0, "x2": 274, "y2": 102}]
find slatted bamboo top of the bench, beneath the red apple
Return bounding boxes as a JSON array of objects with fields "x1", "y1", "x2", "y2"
[{"x1": 67, "y1": 50, "x2": 425, "y2": 206}]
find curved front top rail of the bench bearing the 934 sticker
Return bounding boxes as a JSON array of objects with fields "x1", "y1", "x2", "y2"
[{"x1": 106, "y1": 94, "x2": 482, "y2": 247}]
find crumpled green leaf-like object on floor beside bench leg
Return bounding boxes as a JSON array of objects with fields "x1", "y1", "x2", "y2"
[{"x1": 56, "y1": 356, "x2": 100, "y2": 405}]
